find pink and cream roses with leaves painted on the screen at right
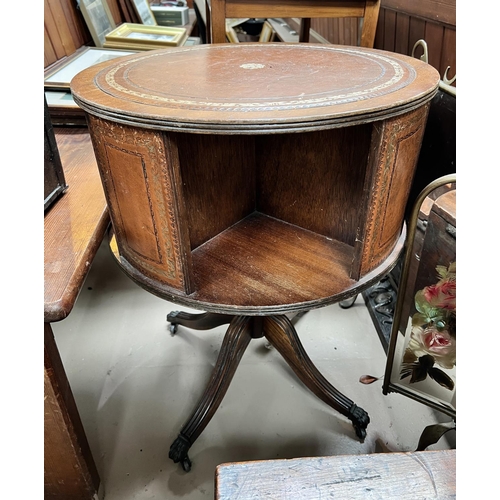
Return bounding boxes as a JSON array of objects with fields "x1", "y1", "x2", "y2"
[{"x1": 401, "y1": 262, "x2": 457, "y2": 391}]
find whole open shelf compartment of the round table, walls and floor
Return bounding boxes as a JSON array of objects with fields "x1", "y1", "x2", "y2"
[{"x1": 161, "y1": 124, "x2": 372, "y2": 307}]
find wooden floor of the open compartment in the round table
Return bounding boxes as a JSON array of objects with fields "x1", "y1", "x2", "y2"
[{"x1": 188, "y1": 212, "x2": 354, "y2": 308}]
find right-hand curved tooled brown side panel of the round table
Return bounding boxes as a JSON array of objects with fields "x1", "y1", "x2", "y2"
[{"x1": 352, "y1": 104, "x2": 429, "y2": 279}]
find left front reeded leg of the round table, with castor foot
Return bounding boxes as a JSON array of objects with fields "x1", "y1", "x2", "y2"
[{"x1": 168, "y1": 316, "x2": 253, "y2": 472}]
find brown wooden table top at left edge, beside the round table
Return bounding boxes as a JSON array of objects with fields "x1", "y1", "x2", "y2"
[{"x1": 44, "y1": 128, "x2": 109, "y2": 323}]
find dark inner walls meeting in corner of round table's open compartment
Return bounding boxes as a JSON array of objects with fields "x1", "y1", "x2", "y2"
[{"x1": 176, "y1": 124, "x2": 372, "y2": 256}]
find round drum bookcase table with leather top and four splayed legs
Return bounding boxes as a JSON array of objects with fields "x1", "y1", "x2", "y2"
[{"x1": 71, "y1": 43, "x2": 439, "y2": 470}]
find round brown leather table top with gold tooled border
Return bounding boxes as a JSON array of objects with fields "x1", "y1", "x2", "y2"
[{"x1": 71, "y1": 43, "x2": 439, "y2": 134}]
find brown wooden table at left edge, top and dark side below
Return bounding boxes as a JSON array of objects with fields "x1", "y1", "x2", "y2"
[{"x1": 44, "y1": 128, "x2": 109, "y2": 500}]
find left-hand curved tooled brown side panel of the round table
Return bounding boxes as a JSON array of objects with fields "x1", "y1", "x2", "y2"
[{"x1": 89, "y1": 117, "x2": 192, "y2": 293}]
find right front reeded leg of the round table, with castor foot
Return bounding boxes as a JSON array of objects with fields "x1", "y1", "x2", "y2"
[{"x1": 263, "y1": 316, "x2": 370, "y2": 439}]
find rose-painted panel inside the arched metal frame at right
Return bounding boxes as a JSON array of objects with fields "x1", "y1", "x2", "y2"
[{"x1": 390, "y1": 191, "x2": 457, "y2": 415}]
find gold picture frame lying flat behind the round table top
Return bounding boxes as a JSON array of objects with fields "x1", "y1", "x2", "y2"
[{"x1": 104, "y1": 23, "x2": 187, "y2": 50}]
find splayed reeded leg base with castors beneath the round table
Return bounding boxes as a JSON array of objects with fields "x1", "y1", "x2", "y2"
[{"x1": 167, "y1": 312, "x2": 370, "y2": 472}]
